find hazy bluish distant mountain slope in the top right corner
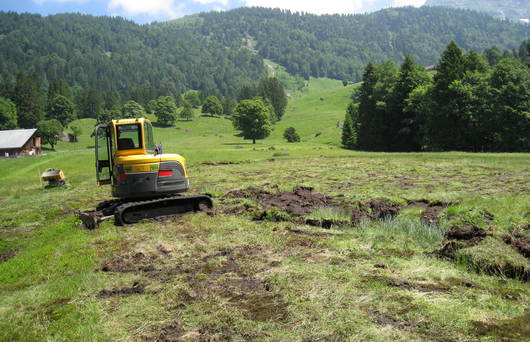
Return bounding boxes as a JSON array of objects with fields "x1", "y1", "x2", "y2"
[{"x1": 425, "y1": 0, "x2": 530, "y2": 20}]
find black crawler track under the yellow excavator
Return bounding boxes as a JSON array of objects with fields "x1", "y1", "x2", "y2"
[{"x1": 114, "y1": 195, "x2": 213, "y2": 226}]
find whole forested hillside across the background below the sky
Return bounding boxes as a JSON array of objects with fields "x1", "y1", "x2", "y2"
[{"x1": 0, "y1": 7, "x2": 530, "y2": 103}]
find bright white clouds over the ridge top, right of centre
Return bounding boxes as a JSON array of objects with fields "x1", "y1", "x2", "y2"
[{"x1": 241, "y1": 0, "x2": 426, "y2": 14}]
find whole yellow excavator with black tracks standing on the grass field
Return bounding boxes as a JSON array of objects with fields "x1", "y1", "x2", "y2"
[{"x1": 79, "y1": 118, "x2": 213, "y2": 229}]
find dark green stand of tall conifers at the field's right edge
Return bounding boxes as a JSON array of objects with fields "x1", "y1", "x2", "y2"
[{"x1": 342, "y1": 39, "x2": 530, "y2": 152}]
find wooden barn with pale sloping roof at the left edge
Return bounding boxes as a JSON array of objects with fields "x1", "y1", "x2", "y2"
[{"x1": 0, "y1": 128, "x2": 42, "y2": 158}]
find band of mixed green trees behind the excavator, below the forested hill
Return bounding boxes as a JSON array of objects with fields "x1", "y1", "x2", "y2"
[{"x1": 0, "y1": 72, "x2": 287, "y2": 148}]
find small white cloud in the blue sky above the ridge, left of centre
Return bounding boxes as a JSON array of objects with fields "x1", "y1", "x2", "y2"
[{"x1": 108, "y1": 0, "x2": 184, "y2": 18}]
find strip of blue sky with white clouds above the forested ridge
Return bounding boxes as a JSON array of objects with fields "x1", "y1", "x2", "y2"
[{"x1": 0, "y1": 0, "x2": 425, "y2": 23}]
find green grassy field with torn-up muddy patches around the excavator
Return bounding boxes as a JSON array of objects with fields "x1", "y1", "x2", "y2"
[{"x1": 0, "y1": 80, "x2": 530, "y2": 341}]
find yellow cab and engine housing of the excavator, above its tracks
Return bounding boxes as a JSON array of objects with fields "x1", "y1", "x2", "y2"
[{"x1": 96, "y1": 118, "x2": 189, "y2": 198}]
